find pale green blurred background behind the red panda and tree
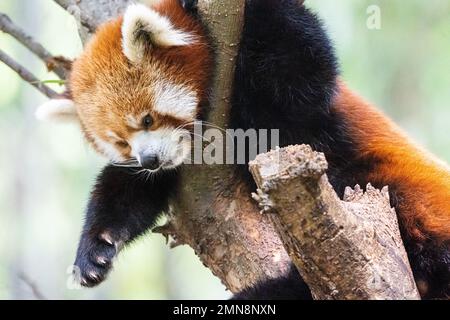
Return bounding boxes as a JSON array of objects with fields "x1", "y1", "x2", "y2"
[{"x1": 0, "y1": 0, "x2": 450, "y2": 299}]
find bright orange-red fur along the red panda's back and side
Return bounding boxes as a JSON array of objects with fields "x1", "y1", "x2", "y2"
[{"x1": 333, "y1": 83, "x2": 450, "y2": 241}]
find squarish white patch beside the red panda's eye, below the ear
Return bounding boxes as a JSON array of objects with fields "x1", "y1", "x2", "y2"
[{"x1": 153, "y1": 80, "x2": 198, "y2": 121}]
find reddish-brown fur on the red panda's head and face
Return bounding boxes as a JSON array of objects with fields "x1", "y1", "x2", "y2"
[{"x1": 70, "y1": 0, "x2": 212, "y2": 156}]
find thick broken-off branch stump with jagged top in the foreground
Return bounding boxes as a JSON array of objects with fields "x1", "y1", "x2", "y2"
[{"x1": 250, "y1": 145, "x2": 420, "y2": 300}]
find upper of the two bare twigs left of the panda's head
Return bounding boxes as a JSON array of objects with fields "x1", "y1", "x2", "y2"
[{"x1": 0, "y1": 12, "x2": 69, "y2": 79}]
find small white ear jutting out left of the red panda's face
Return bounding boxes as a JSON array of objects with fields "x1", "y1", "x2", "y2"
[{"x1": 35, "y1": 99, "x2": 78, "y2": 122}]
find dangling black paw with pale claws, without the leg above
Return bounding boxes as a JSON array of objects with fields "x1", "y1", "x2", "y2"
[{"x1": 73, "y1": 232, "x2": 124, "y2": 287}]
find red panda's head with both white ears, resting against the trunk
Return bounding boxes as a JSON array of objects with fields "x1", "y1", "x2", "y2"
[{"x1": 37, "y1": 0, "x2": 212, "y2": 170}]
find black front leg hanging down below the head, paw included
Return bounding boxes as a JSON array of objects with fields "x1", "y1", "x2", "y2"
[{"x1": 74, "y1": 166, "x2": 176, "y2": 287}]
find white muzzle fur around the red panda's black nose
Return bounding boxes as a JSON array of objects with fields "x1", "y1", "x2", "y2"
[{"x1": 130, "y1": 128, "x2": 191, "y2": 169}]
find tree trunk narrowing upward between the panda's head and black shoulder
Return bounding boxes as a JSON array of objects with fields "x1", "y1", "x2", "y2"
[{"x1": 158, "y1": 0, "x2": 289, "y2": 292}]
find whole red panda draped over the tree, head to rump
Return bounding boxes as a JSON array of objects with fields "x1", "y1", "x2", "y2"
[{"x1": 38, "y1": 0, "x2": 450, "y2": 299}]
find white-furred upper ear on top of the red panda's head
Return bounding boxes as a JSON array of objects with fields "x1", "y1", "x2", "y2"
[{"x1": 122, "y1": 4, "x2": 194, "y2": 63}]
